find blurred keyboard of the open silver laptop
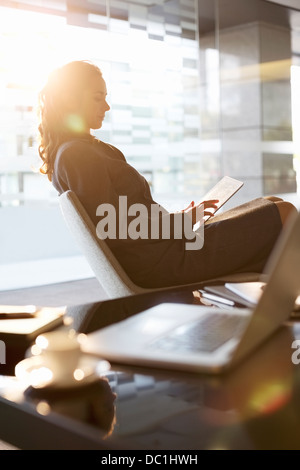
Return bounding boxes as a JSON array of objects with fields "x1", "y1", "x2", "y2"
[{"x1": 151, "y1": 314, "x2": 249, "y2": 353}]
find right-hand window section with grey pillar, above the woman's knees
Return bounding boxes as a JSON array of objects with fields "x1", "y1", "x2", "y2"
[{"x1": 199, "y1": 0, "x2": 300, "y2": 204}]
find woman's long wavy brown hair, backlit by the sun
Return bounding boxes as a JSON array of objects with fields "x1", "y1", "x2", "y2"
[{"x1": 38, "y1": 61, "x2": 102, "y2": 181}]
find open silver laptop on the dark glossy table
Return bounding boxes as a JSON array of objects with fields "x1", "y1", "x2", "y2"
[{"x1": 83, "y1": 214, "x2": 300, "y2": 374}]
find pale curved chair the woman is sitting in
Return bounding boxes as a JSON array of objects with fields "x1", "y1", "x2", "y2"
[{"x1": 59, "y1": 190, "x2": 259, "y2": 298}]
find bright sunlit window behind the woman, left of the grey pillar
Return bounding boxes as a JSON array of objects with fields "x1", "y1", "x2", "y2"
[{"x1": 0, "y1": 0, "x2": 200, "y2": 210}]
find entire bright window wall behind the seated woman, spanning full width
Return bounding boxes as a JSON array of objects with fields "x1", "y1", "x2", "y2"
[{"x1": 0, "y1": 0, "x2": 300, "y2": 288}]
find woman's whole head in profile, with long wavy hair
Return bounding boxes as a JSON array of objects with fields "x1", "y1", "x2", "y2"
[{"x1": 39, "y1": 61, "x2": 110, "y2": 180}]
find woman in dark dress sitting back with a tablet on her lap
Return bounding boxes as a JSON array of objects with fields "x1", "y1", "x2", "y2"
[{"x1": 39, "y1": 61, "x2": 296, "y2": 287}]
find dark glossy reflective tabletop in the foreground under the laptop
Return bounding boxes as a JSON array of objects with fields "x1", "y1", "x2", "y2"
[{"x1": 0, "y1": 290, "x2": 300, "y2": 452}]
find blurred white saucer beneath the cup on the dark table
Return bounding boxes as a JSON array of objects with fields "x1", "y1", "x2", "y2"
[{"x1": 15, "y1": 354, "x2": 110, "y2": 389}]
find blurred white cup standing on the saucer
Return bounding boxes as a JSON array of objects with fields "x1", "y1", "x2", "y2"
[{"x1": 35, "y1": 331, "x2": 81, "y2": 380}]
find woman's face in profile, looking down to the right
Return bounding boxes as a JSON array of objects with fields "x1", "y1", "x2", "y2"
[{"x1": 80, "y1": 74, "x2": 110, "y2": 132}]
